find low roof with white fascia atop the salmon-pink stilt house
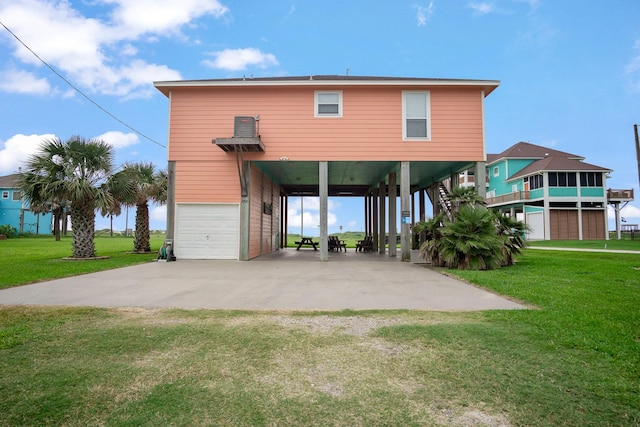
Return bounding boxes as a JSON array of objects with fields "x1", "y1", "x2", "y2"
[{"x1": 153, "y1": 75, "x2": 500, "y2": 96}]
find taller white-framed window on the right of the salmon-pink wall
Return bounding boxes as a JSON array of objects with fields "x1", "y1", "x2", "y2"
[{"x1": 402, "y1": 91, "x2": 431, "y2": 141}]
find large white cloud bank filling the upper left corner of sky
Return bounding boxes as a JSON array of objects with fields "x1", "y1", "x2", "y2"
[{"x1": 0, "y1": 0, "x2": 227, "y2": 96}]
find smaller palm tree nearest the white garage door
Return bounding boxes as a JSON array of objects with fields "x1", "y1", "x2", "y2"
[{"x1": 119, "y1": 163, "x2": 168, "y2": 253}]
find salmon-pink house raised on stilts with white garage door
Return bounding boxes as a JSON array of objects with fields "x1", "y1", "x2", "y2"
[{"x1": 154, "y1": 76, "x2": 499, "y2": 261}]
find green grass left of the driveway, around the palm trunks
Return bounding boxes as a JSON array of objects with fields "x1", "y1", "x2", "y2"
[{"x1": 0, "y1": 235, "x2": 164, "y2": 289}]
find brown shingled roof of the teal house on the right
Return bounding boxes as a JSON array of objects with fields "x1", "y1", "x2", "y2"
[{"x1": 487, "y1": 142, "x2": 612, "y2": 181}]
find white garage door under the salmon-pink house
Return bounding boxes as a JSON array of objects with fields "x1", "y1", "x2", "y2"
[{"x1": 174, "y1": 204, "x2": 240, "y2": 260}]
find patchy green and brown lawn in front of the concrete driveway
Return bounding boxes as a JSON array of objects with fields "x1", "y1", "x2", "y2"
[{"x1": 0, "y1": 240, "x2": 640, "y2": 426}]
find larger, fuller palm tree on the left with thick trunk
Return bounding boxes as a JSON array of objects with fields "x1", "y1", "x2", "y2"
[{"x1": 19, "y1": 136, "x2": 128, "y2": 258}]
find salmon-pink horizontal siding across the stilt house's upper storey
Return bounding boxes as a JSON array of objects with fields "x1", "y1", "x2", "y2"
[{"x1": 169, "y1": 86, "x2": 484, "y2": 164}]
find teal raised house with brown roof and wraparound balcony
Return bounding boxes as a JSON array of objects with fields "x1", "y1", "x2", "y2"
[{"x1": 486, "y1": 142, "x2": 612, "y2": 240}]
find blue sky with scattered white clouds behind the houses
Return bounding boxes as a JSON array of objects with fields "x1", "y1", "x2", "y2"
[{"x1": 0, "y1": 0, "x2": 640, "y2": 234}]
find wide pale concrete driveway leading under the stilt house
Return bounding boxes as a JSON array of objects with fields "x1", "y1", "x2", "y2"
[{"x1": 0, "y1": 249, "x2": 526, "y2": 311}]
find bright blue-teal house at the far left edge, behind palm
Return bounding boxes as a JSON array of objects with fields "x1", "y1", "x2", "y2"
[{"x1": 0, "y1": 174, "x2": 53, "y2": 234}]
